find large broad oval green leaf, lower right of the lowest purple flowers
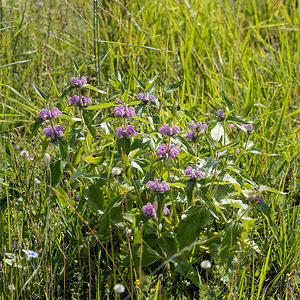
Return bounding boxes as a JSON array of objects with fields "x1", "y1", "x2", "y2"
[{"x1": 176, "y1": 206, "x2": 211, "y2": 249}]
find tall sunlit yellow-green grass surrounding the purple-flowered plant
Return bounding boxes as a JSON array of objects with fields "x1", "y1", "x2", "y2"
[{"x1": 0, "y1": 0, "x2": 300, "y2": 299}]
